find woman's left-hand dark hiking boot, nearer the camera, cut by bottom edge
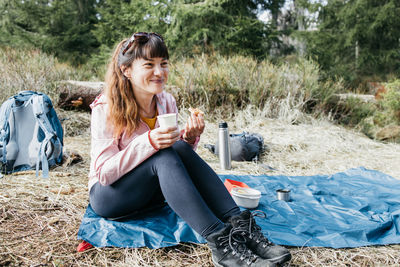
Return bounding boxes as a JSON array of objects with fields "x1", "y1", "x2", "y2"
[{"x1": 207, "y1": 224, "x2": 275, "y2": 267}]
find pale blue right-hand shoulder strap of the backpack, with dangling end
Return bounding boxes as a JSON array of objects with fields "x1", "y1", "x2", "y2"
[{"x1": 31, "y1": 95, "x2": 61, "y2": 178}]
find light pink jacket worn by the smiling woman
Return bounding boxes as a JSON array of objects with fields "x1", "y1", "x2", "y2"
[{"x1": 89, "y1": 92, "x2": 199, "y2": 191}]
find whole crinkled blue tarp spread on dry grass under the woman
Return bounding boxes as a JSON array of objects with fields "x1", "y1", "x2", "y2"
[{"x1": 78, "y1": 167, "x2": 400, "y2": 248}]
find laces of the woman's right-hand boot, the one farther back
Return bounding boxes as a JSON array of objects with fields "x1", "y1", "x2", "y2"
[{"x1": 238, "y1": 210, "x2": 273, "y2": 248}]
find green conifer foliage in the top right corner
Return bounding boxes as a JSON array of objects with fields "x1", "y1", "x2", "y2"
[{"x1": 308, "y1": 0, "x2": 400, "y2": 82}]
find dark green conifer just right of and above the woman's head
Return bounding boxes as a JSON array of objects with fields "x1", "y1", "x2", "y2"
[{"x1": 167, "y1": 0, "x2": 273, "y2": 57}]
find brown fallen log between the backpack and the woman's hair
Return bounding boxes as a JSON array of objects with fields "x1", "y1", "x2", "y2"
[{"x1": 57, "y1": 81, "x2": 104, "y2": 111}]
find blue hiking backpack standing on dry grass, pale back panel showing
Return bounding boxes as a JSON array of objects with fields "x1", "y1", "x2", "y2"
[{"x1": 0, "y1": 91, "x2": 63, "y2": 178}]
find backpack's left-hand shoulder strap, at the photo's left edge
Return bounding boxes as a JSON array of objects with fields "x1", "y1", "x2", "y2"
[{"x1": 0, "y1": 97, "x2": 15, "y2": 170}]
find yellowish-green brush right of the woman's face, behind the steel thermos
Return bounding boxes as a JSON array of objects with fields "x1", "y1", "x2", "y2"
[{"x1": 169, "y1": 54, "x2": 340, "y2": 117}]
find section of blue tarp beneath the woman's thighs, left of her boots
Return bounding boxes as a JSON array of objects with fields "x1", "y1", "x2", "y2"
[{"x1": 78, "y1": 205, "x2": 205, "y2": 248}]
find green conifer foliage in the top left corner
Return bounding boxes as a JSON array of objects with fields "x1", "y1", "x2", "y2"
[{"x1": 0, "y1": 0, "x2": 98, "y2": 64}]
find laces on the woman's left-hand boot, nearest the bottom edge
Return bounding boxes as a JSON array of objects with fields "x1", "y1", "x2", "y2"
[{"x1": 218, "y1": 228, "x2": 258, "y2": 265}]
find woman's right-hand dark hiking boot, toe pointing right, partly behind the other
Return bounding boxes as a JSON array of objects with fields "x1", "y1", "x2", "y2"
[{"x1": 229, "y1": 210, "x2": 292, "y2": 264}]
